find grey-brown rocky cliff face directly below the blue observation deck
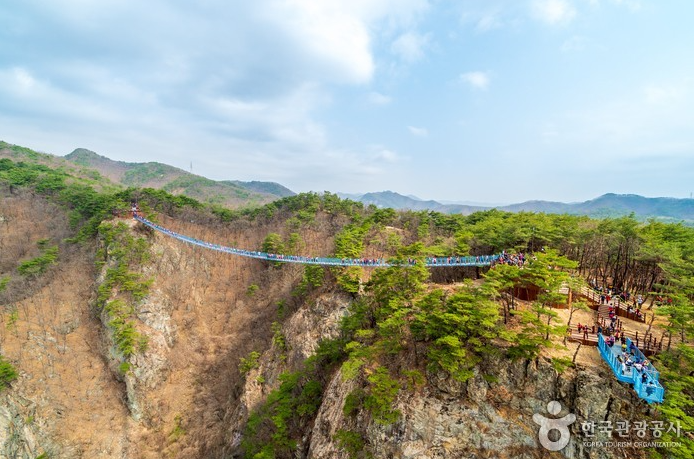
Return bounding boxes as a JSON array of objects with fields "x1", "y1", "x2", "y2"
[{"x1": 307, "y1": 359, "x2": 648, "y2": 459}]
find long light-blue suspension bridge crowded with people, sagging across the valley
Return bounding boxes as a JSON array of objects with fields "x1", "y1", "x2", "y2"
[{"x1": 133, "y1": 217, "x2": 503, "y2": 268}]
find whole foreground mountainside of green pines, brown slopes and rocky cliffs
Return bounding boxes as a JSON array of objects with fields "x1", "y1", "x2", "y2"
[{"x1": 0, "y1": 155, "x2": 694, "y2": 459}]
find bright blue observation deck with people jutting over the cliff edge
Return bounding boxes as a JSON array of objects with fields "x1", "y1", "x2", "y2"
[{"x1": 598, "y1": 333, "x2": 665, "y2": 403}]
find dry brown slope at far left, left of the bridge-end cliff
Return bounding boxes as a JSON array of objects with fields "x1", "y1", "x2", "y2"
[{"x1": 0, "y1": 189, "x2": 134, "y2": 459}]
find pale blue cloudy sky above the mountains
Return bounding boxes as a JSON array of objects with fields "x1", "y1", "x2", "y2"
[{"x1": 0, "y1": 0, "x2": 694, "y2": 203}]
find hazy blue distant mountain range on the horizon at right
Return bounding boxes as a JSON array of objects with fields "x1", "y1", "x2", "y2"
[{"x1": 338, "y1": 191, "x2": 694, "y2": 225}]
